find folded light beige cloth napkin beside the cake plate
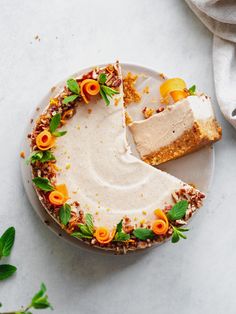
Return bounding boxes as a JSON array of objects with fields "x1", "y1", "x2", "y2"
[{"x1": 185, "y1": 0, "x2": 236, "y2": 128}]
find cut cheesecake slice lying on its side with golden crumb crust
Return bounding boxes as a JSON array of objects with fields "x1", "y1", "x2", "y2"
[{"x1": 129, "y1": 79, "x2": 222, "y2": 165}]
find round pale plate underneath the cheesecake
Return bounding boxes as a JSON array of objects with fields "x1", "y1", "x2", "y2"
[{"x1": 21, "y1": 64, "x2": 214, "y2": 252}]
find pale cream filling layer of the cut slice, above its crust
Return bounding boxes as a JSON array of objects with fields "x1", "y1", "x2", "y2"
[{"x1": 129, "y1": 96, "x2": 214, "y2": 157}]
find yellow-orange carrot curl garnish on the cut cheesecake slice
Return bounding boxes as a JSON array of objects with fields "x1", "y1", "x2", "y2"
[{"x1": 160, "y1": 78, "x2": 188, "y2": 102}]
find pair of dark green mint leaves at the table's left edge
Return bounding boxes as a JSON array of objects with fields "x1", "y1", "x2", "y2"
[{"x1": 0, "y1": 227, "x2": 17, "y2": 280}]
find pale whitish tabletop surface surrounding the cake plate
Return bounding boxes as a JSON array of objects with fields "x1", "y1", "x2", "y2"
[{"x1": 0, "y1": 0, "x2": 236, "y2": 314}]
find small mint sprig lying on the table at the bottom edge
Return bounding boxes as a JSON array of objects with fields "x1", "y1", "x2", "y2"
[{"x1": 0, "y1": 283, "x2": 53, "y2": 314}]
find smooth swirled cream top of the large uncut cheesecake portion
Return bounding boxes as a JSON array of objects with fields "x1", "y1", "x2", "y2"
[{"x1": 54, "y1": 70, "x2": 190, "y2": 228}]
